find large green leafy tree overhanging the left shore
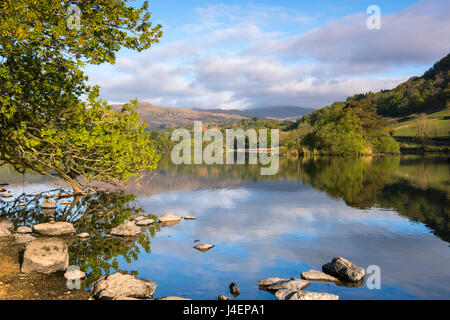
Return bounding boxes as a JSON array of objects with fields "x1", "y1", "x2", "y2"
[{"x1": 0, "y1": 0, "x2": 162, "y2": 193}]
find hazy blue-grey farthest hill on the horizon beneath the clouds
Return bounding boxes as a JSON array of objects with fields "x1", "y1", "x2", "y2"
[{"x1": 194, "y1": 106, "x2": 314, "y2": 121}]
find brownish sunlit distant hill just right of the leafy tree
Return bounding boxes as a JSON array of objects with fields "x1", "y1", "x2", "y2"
[{"x1": 112, "y1": 102, "x2": 246, "y2": 129}]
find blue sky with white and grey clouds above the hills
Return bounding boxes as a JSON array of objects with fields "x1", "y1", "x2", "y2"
[{"x1": 86, "y1": 0, "x2": 450, "y2": 109}]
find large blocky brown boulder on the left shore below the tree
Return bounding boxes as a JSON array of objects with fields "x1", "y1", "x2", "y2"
[{"x1": 21, "y1": 238, "x2": 69, "y2": 274}]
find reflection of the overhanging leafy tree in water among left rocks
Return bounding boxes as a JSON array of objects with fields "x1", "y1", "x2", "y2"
[{"x1": 0, "y1": 190, "x2": 160, "y2": 289}]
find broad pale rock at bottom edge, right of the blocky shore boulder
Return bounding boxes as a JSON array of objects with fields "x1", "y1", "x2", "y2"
[{"x1": 91, "y1": 272, "x2": 156, "y2": 300}]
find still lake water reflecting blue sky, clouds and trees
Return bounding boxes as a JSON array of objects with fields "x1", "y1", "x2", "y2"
[{"x1": 0, "y1": 156, "x2": 450, "y2": 299}]
